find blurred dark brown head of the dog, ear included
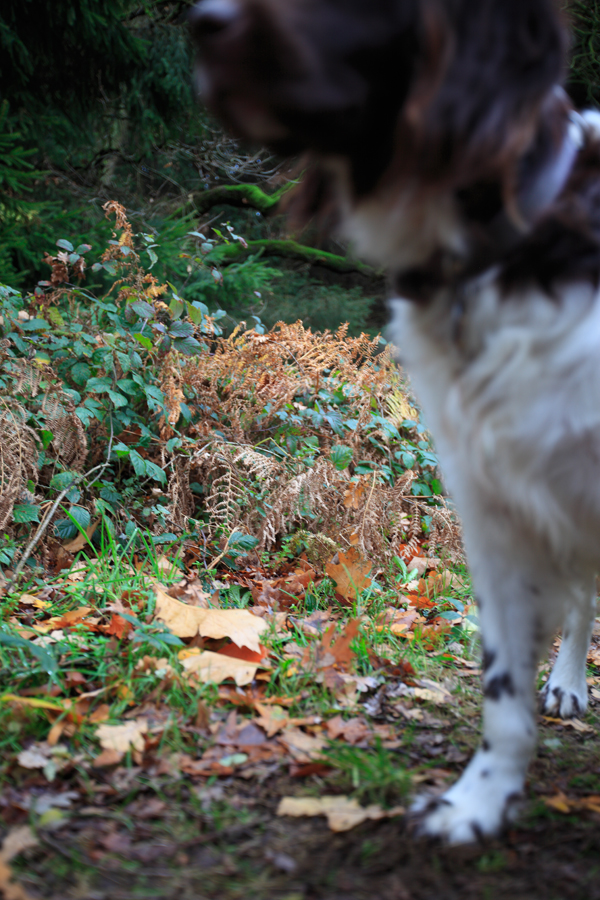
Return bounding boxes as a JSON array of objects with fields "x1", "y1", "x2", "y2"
[{"x1": 191, "y1": 0, "x2": 564, "y2": 224}]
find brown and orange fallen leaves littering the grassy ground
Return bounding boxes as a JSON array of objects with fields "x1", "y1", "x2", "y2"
[{"x1": 0, "y1": 546, "x2": 600, "y2": 900}]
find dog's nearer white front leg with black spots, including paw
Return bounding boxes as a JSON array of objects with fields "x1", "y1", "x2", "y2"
[{"x1": 414, "y1": 504, "x2": 567, "y2": 843}]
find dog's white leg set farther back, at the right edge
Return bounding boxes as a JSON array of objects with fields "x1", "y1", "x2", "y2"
[{"x1": 541, "y1": 585, "x2": 596, "y2": 719}]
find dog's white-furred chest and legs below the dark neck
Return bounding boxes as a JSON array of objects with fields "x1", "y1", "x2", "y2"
[{"x1": 384, "y1": 271, "x2": 600, "y2": 843}]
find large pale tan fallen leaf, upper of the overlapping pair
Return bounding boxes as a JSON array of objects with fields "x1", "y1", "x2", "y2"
[{"x1": 154, "y1": 584, "x2": 268, "y2": 653}]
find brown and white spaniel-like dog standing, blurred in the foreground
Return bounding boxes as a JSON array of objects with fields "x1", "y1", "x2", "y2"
[{"x1": 191, "y1": 0, "x2": 600, "y2": 844}]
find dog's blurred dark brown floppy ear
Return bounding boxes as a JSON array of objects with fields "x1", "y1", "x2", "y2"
[{"x1": 398, "y1": 0, "x2": 566, "y2": 186}]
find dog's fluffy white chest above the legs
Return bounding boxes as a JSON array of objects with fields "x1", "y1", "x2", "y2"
[{"x1": 391, "y1": 276, "x2": 600, "y2": 566}]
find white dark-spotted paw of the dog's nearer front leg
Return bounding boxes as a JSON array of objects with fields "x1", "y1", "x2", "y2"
[{"x1": 411, "y1": 751, "x2": 522, "y2": 844}]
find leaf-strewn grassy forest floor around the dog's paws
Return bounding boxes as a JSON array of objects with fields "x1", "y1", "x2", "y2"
[{"x1": 0, "y1": 544, "x2": 600, "y2": 900}]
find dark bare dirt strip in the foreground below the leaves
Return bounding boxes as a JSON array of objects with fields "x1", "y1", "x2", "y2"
[{"x1": 13, "y1": 704, "x2": 600, "y2": 900}]
